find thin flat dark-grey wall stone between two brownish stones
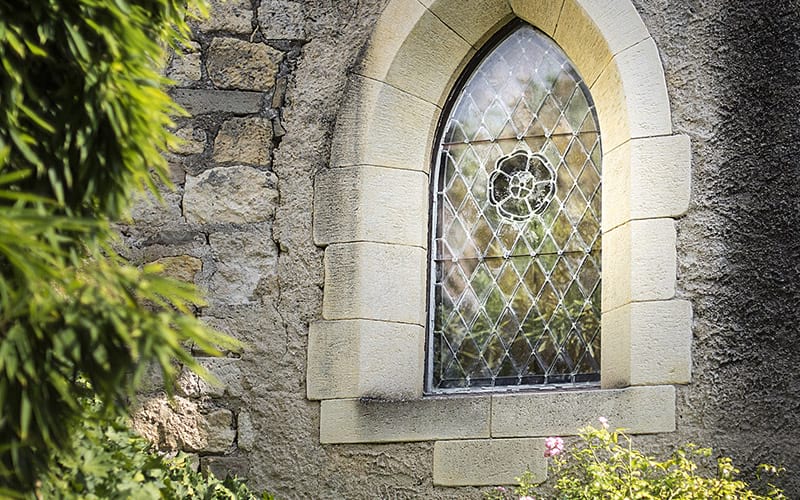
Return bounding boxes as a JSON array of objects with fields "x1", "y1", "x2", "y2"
[{"x1": 169, "y1": 89, "x2": 264, "y2": 116}]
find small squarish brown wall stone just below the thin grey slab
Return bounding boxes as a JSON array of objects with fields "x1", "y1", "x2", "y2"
[{"x1": 214, "y1": 117, "x2": 272, "y2": 165}]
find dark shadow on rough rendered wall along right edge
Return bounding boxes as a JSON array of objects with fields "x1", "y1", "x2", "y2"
[{"x1": 692, "y1": 0, "x2": 800, "y2": 497}]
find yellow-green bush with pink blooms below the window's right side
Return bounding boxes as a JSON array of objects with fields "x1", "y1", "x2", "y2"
[{"x1": 486, "y1": 417, "x2": 787, "y2": 500}]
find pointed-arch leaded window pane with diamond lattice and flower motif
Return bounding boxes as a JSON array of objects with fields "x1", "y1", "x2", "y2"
[{"x1": 428, "y1": 21, "x2": 601, "y2": 393}]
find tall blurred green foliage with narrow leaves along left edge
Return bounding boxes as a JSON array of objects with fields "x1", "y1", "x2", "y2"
[{"x1": 0, "y1": 0, "x2": 244, "y2": 495}]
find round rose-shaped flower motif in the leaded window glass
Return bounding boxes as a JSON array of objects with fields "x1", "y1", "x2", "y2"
[{"x1": 489, "y1": 150, "x2": 556, "y2": 221}]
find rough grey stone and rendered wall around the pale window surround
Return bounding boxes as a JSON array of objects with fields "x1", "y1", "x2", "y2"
[{"x1": 122, "y1": 0, "x2": 800, "y2": 498}]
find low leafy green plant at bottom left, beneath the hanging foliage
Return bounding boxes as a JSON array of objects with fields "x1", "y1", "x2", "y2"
[{"x1": 37, "y1": 402, "x2": 272, "y2": 500}]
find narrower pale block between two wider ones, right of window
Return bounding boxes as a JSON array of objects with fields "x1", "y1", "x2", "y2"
[{"x1": 602, "y1": 219, "x2": 677, "y2": 311}]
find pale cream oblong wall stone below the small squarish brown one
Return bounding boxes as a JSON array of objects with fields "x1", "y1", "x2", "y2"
[{"x1": 183, "y1": 166, "x2": 278, "y2": 224}]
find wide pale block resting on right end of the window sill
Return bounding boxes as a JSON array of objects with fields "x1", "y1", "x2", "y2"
[{"x1": 600, "y1": 300, "x2": 692, "y2": 387}]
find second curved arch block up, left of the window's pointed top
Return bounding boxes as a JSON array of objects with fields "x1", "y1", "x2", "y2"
[{"x1": 356, "y1": 2, "x2": 475, "y2": 106}]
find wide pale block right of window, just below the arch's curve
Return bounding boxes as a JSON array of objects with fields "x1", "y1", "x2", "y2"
[{"x1": 603, "y1": 135, "x2": 692, "y2": 231}]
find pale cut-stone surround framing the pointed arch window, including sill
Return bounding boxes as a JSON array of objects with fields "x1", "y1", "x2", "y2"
[{"x1": 307, "y1": 0, "x2": 692, "y2": 486}]
